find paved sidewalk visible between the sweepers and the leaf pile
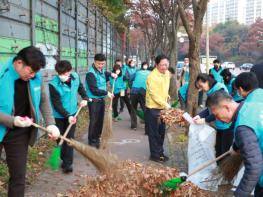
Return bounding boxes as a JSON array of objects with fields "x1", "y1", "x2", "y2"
[{"x1": 25, "y1": 111, "x2": 154, "y2": 197}]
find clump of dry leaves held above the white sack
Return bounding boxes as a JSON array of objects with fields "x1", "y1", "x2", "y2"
[{"x1": 160, "y1": 108, "x2": 185, "y2": 126}]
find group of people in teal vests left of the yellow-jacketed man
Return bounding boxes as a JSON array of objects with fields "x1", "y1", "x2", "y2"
[{"x1": 0, "y1": 46, "x2": 165, "y2": 197}]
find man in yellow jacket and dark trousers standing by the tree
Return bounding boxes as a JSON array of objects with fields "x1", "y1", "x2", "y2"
[{"x1": 145, "y1": 55, "x2": 171, "y2": 162}]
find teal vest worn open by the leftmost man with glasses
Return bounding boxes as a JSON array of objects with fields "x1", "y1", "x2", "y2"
[{"x1": 0, "y1": 59, "x2": 42, "y2": 142}]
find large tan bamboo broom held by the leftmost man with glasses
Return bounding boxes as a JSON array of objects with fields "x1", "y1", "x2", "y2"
[{"x1": 32, "y1": 123, "x2": 118, "y2": 173}]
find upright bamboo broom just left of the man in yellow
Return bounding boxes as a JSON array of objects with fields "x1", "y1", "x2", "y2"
[{"x1": 100, "y1": 79, "x2": 116, "y2": 149}]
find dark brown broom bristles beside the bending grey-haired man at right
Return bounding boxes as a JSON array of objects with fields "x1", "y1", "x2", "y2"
[{"x1": 213, "y1": 154, "x2": 243, "y2": 182}]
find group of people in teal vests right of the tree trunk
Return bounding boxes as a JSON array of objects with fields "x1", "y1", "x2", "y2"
[{"x1": 179, "y1": 59, "x2": 263, "y2": 197}]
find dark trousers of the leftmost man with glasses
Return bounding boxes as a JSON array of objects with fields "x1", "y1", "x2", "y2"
[{"x1": 1, "y1": 128, "x2": 30, "y2": 197}]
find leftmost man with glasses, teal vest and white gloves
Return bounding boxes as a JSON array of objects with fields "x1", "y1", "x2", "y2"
[{"x1": 0, "y1": 46, "x2": 59, "y2": 197}]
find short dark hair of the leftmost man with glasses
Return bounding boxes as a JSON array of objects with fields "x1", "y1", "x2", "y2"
[{"x1": 13, "y1": 46, "x2": 46, "y2": 72}]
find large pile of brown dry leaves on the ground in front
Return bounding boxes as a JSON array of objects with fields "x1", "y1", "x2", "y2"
[{"x1": 66, "y1": 161, "x2": 213, "y2": 197}]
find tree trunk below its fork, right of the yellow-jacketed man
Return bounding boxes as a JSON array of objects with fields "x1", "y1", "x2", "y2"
[{"x1": 186, "y1": 37, "x2": 200, "y2": 116}]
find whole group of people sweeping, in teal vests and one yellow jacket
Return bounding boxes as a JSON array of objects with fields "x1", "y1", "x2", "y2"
[{"x1": 0, "y1": 46, "x2": 263, "y2": 197}]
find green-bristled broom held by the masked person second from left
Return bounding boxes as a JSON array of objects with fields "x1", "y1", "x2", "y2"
[{"x1": 47, "y1": 106, "x2": 82, "y2": 170}]
